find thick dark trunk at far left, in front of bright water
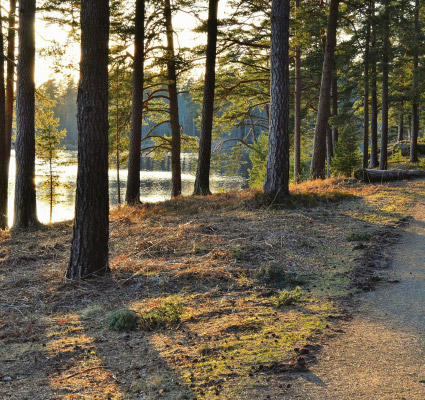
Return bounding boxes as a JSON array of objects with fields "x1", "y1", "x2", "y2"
[{"x1": 14, "y1": 0, "x2": 38, "y2": 228}]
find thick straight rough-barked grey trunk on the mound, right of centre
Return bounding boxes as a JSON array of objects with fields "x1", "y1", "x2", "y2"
[{"x1": 264, "y1": 0, "x2": 290, "y2": 197}]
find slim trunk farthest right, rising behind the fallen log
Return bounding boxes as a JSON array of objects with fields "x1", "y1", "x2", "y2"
[{"x1": 410, "y1": 0, "x2": 420, "y2": 162}]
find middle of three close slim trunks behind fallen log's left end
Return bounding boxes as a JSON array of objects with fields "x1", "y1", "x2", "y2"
[{"x1": 370, "y1": 0, "x2": 379, "y2": 168}]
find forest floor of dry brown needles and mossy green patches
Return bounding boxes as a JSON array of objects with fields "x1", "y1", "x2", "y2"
[{"x1": 0, "y1": 180, "x2": 425, "y2": 400}]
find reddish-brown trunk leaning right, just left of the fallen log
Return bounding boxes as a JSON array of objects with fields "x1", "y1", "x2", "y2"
[{"x1": 311, "y1": 0, "x2": 339, "y2": 179}]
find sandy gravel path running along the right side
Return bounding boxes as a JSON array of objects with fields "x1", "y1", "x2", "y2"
[{"x1": 286, "y1": 199, "x2": 425, "y2": 400}]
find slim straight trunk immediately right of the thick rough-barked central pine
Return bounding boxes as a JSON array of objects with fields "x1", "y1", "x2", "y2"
[{"x1": 294, "y1": 0, "x2": 302, "y2": 183}]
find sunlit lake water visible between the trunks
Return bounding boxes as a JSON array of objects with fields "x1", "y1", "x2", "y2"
[{"x1": 8, "y1": 150, "x2": 247, "y2": 225}]
